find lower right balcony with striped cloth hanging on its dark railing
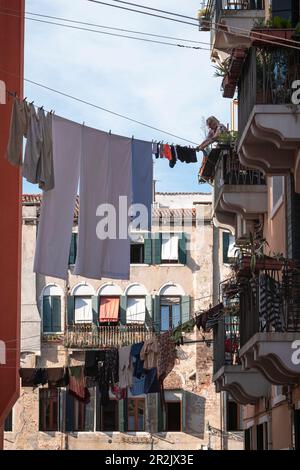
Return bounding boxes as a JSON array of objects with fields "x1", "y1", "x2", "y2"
[{"x1": 240, "y1": 265, "x2": 300, "y2": 385}]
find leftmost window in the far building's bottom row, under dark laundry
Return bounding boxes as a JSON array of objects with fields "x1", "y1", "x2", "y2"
[{"x1": 39, "y1": 388, "x2": 59, "y2": 431}]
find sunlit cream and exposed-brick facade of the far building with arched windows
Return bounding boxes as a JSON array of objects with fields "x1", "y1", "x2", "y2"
[{"x1": 4, "y1": 193, "x2": 241, "y2": 450}]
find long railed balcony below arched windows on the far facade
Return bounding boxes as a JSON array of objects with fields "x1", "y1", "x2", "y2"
[{"x1": 65, "y1": 324, "x2": 154, "y2": 349}]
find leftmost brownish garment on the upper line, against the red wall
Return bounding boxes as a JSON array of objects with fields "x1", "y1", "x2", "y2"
[{"x1": 7, "y1": 97, "x2": 30, "y2": 165}]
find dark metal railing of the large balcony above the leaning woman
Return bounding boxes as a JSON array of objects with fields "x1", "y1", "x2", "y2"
[{"x1": 238, "y1": 47, "x2": 300, "y2": 136}]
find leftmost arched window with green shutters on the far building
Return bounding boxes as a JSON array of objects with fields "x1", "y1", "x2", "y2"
[{"x1": 43, "y1": 284, "x2": 63, "y2": 333}]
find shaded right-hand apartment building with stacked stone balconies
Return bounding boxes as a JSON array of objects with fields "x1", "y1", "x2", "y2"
[{"x1": 200, "y1": 0, "x2": 300, "y2": 450}]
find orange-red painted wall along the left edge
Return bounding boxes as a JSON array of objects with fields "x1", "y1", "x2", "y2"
[{"x1": 0, "y1": 0, "x2": 25, "y2": 442}]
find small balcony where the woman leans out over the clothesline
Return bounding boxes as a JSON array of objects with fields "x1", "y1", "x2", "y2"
[{"x1": 214, "y1": 147, "x2": 268, "y2": 234}]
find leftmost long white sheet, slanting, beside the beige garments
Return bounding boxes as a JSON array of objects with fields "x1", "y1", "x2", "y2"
[{"x1": 34, "y1": 115, "x2": 82, "y2": 279}]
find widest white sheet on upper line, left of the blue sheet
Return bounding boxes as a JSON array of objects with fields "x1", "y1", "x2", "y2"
[{"x1": 74, "y1": 126, "x2": 132, "y2": 279}]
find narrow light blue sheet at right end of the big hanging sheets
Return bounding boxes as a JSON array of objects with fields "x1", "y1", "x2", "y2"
[{"x1": 132, "y1": 139, "x2": 153, "y2": 230}]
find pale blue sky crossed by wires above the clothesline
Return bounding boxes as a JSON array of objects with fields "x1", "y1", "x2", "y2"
[{"x1": 23, "y1": 0, "x2": 230, "y2": 192}]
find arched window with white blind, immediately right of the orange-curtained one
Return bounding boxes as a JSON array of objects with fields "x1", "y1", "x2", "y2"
[{"x1": 125, "y1": 283, "x2": 148, "y2": 324}]
